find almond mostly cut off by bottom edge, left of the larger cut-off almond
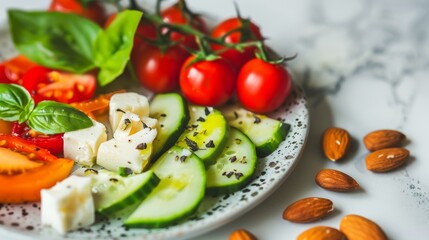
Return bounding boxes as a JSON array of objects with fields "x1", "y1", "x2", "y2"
[{"x1": 296, "y1": 226, "x2": 346, "y2": 240}]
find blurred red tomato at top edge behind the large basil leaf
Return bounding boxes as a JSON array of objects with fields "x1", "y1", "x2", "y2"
[{"x1": 48, "y1": 0, "x2": 107, "y2": 25}]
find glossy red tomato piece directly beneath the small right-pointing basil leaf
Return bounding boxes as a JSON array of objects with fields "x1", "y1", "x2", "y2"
[{"x1": 12, "y1": 122, "x2": 64, "y2": 154}]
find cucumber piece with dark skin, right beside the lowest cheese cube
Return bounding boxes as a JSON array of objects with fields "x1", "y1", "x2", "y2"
[{"x1": 76, "y1": 168, "x2": 160, "y2": 215}]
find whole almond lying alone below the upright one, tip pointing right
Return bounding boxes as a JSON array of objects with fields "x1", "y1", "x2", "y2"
[{"x1": 315, "y1": 169, "x2": 359, "y2": 192}]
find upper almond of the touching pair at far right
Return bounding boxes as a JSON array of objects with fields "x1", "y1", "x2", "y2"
[{"x1": 363, "y1": 129, "x2": 405, "y2": 151}]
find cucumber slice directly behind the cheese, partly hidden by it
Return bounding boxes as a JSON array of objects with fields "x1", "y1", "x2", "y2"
[{"x1": 149, "y1": 93, "x2": 189, "y2": 161}]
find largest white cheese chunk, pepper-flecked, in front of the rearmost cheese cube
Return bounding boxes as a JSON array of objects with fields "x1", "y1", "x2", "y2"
[{"x1": 97, "y1": 127, "x2": 157, "y2": 173}]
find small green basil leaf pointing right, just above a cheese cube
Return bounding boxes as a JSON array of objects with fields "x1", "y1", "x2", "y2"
[{"x1": 27, "y1": 101, "x2": 93, "y2": 134}]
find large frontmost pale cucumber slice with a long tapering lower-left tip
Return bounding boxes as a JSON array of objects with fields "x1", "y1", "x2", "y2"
[{"x1": 124, "y1": 146, "x2": 206, "y2": 228}]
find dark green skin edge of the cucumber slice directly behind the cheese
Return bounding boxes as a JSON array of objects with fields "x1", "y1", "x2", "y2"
[{"x1": 150, "y1": 93, "x2": 190, "y2": 164}]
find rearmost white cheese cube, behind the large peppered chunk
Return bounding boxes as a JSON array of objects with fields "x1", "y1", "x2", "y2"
[{"x1": 109, "y1": 92, "x2": 149, "y2": 132}]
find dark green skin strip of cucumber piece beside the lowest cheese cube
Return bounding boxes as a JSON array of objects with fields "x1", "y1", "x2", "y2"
[{"x1": 97, "y1": 173, "x2": 161, "y2": 216}]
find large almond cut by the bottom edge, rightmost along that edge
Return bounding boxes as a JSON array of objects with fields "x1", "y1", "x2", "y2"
[{"x1": 340, "y1": 214, "x2": 387, "y2": 240}]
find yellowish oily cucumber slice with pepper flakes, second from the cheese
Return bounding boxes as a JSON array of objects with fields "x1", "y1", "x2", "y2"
[{"x1": 176, "y1": 106, "x2": 229, "y2": 165}]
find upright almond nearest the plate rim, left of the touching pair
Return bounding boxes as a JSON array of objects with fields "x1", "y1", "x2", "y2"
[{"x1": 322, "y1": 127, "x2": 350, "y2": 161}]
